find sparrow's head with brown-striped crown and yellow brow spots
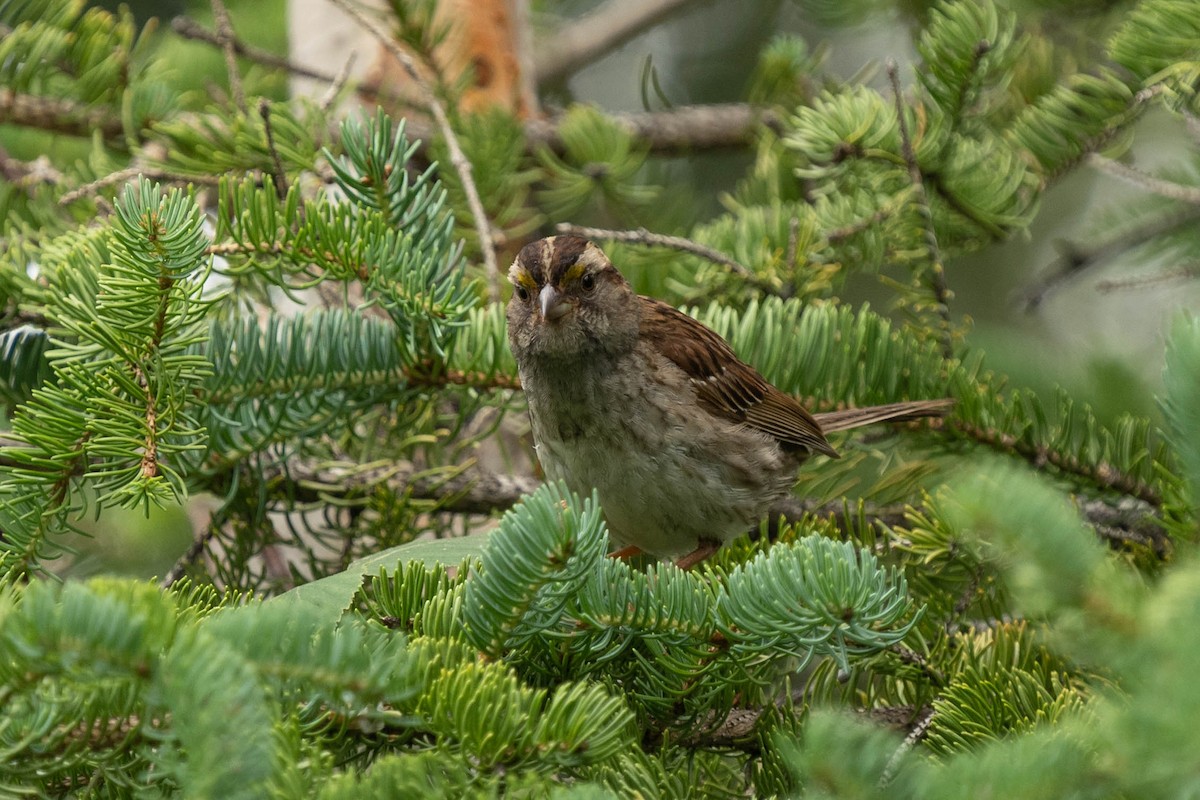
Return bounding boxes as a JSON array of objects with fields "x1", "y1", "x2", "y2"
[{"x1": 508, "y1": 236, "x2": 641, "y2": 361}]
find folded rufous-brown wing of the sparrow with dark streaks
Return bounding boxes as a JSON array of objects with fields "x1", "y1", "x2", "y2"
[{"x1": 642, "y1": 297, "x2": 838, "y2": 458}]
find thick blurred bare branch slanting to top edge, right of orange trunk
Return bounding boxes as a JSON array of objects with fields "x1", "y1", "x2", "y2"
[{"x1": 534, "y1": 0, "x2": 689, "y2": 85}]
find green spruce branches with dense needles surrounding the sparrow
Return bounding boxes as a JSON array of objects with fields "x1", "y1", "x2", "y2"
[{"x1": 0, "y1": 0, "x2": 1200, "y2": 798}]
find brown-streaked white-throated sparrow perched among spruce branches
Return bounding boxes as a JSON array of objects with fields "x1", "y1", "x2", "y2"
[{"x1": 508, "y1": 236, "x2": 949, "y2": 565}]
